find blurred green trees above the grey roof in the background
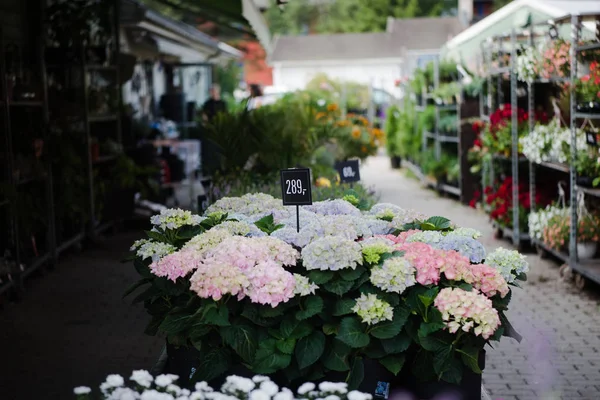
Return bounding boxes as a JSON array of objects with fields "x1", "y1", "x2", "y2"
[{"x1": 266, "y1": 0, "x2": 456, "y2": 35}]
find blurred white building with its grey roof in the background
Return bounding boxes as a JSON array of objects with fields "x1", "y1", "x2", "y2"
[{"x1": 268, "y1": 17, "x2": 462, "y2": 97}]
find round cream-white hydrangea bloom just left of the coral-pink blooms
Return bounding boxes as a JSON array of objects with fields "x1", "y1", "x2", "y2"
[{"x1": 370, "y1": 257, "x2": 417, "y2": 294}]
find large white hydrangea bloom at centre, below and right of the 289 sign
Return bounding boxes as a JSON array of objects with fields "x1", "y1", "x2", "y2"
[{"x1": 302, "y1": 236, "x2": 362, "y2": 271}]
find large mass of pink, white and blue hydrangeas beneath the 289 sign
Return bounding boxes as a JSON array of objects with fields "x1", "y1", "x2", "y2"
[{"x1": 127, "y1": 194, "x2": 527, "y2": 389}]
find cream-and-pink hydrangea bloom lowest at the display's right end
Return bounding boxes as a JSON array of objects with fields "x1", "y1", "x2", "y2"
[{"x1": 433, "y1": 288, "x2": 500, "y2": 339}]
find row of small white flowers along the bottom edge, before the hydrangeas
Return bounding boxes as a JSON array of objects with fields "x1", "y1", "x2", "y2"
[{"x1": 73, "y1": 370, "x2": 373, "y2": 400}]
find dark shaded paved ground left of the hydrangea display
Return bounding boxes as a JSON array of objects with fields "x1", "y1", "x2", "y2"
[{"x1": 0, "y1": 231, "x2": 163, "y2": 400}]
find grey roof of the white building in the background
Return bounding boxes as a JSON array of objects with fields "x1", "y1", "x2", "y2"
[{"x1": 269, "y1": 17, "x2": 460, "y2": 62}]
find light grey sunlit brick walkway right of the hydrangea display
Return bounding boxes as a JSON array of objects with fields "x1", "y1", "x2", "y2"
[{"x1": 361, "y1": 157, "x2": 600, "y2": 400}]
